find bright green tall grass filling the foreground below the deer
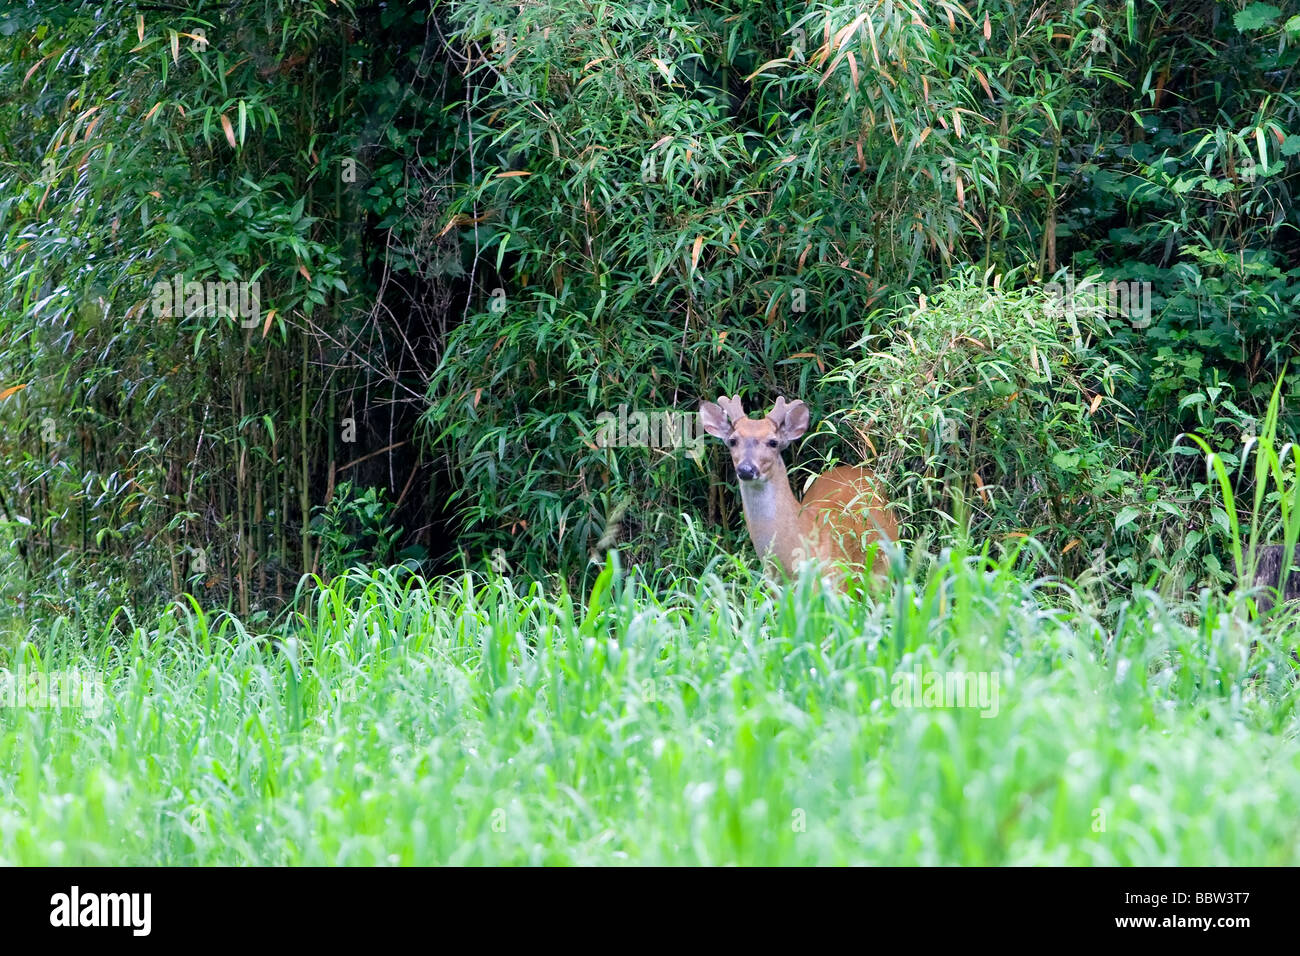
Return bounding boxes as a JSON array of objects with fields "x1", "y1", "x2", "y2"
[{"x1": 0, "y1": 550, "x2": 1300, "y2": 864}]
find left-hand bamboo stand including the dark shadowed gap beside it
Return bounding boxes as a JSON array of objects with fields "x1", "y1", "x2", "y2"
[{"x1": 0, "y1": 0, "x2": 450, "y2": 624}]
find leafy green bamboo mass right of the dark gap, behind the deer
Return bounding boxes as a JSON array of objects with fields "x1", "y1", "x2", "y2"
[{"x1": 429, "y1": 0, "x2": 1300, "y2": 587}]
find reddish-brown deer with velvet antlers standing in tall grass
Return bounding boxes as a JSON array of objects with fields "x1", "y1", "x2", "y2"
[{"x1": 699, "y1": 395, "x2": 898, "y2": 591}]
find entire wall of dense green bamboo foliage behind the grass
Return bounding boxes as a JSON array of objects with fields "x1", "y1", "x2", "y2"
[{"x1": 0, "y1": 0, "x2": 1300, "y2": 614}]
